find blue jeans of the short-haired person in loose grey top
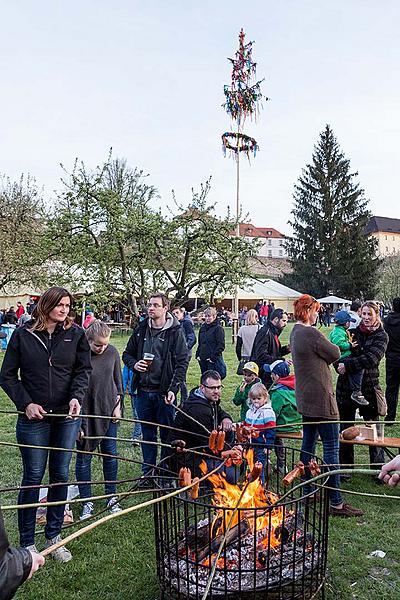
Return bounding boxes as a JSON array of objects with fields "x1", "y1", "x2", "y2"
[{"x1": 75, "y1": 421, "x2": 118, "y2": 498}]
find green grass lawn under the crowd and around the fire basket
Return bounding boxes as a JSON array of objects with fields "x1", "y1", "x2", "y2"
[{"x1": 0, "y1": 325, "x2": 400, "y2": 600}]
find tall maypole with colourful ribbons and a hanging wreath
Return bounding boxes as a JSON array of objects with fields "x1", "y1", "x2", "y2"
[{"x1": 222, "y1": 29, "x2": 268, "y2": 338}]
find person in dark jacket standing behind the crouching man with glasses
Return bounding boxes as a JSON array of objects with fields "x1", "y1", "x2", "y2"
[{"x1": 196, "y1": 306, "x2": 226, "y2": 379}]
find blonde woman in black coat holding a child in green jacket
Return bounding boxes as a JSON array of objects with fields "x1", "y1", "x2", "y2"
[{"x1": 336, "y1": 301, "x2": 388, "y2": 464}]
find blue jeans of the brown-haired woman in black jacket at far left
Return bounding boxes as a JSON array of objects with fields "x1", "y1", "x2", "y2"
[{"x1": 16, "y1": 415, "x2": 80, "y2": 546}]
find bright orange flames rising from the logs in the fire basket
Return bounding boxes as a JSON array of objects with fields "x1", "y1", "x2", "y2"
[{"x1": 200, "y1": 449, "x2": 283, "y2": 547}]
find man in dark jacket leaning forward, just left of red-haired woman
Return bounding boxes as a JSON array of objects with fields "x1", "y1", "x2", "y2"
[{"x1": 251, "y1": 308, "x2": 290, "y2": 385}]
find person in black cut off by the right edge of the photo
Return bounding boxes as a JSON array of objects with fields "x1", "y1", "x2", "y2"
[{"x1": 383, "y1": 298, "x2": 400, "y2": 424}]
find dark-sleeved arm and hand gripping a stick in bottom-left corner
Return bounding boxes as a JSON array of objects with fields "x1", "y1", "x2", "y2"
[{"x1": 0, "y1": 509, "x2": 44, "y2": 600}]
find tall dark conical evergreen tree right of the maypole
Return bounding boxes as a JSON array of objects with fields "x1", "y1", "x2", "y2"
[{"x1": 286, "y1": 125, "x2": 379, "y2": 299}]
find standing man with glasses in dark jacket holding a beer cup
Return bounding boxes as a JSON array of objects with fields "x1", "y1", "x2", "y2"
[{"x1": 122, "y1": 293, "x2": 188, "y2": 475}]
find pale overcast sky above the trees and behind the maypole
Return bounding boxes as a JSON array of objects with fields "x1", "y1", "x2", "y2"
[{"x1": 0, "y1": 0, "x2": 400, "y2": 233}]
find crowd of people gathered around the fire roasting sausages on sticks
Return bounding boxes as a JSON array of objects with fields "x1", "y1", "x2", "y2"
[{"x1": 0, "y1": 287, "x2": 400, "y2": 599}]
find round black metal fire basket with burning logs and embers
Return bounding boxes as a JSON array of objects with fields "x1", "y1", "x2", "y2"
[{"x1": 155, "y1": 442, "x2": 328, "y2": 600}]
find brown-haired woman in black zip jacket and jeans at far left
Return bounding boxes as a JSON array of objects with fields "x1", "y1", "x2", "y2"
[{"x1": 0, "y1": 287, "x2": 91, "y2": 562}]
